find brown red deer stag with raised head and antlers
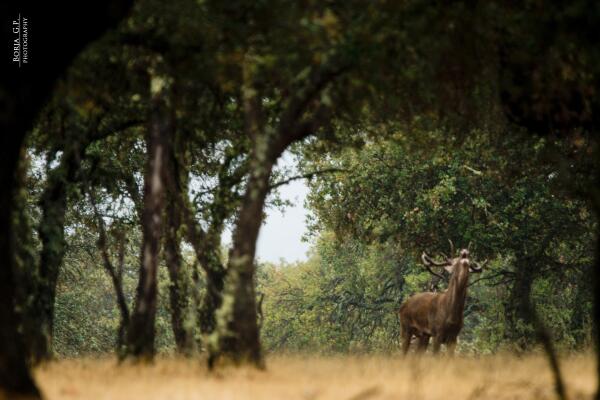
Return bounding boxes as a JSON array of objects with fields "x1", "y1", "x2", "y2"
[{"x1": 400, "y1": 241, "x2": 487, "y2": 355}]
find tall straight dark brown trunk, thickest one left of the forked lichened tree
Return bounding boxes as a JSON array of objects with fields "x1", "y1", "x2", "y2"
[{"x1": 125, "y1": 77, "x2": 168, "y2": 359}]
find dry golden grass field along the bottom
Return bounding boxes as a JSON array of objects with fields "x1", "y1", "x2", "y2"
[{"x1": 35, "y1": 355, "x2": 596, "y2": 400}]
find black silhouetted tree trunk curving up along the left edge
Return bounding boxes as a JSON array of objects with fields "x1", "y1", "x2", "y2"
[{"x1": 0, "y1": 1, "x2": 132, "y2": 398}]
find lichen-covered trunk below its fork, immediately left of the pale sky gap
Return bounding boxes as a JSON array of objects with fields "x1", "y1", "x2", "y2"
[{"x1": 209, "y1": 147, "x2": 274, "y2": 367}]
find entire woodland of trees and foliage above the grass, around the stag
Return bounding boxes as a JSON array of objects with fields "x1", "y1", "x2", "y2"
[{"x1": 0, "y1": 0, "x2": 600, "y2": 396}]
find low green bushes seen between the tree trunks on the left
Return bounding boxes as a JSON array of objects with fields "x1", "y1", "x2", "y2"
[{"x1": 54, "y1": 236, "x2": 175, "y2": 357}]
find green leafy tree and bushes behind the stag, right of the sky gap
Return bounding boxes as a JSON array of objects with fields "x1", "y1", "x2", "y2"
[{"x1": 259, "y1": 132, "x2": 594, "y2": 353}]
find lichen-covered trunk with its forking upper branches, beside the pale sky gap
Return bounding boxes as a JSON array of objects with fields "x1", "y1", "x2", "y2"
[{"x1": 208, "y1": 54, "x2": 338, "y2": 368}]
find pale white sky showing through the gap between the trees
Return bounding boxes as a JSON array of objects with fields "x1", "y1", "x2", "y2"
[{"x1": 223, "y1": 154, "x2": 309, "y2": 262}]
